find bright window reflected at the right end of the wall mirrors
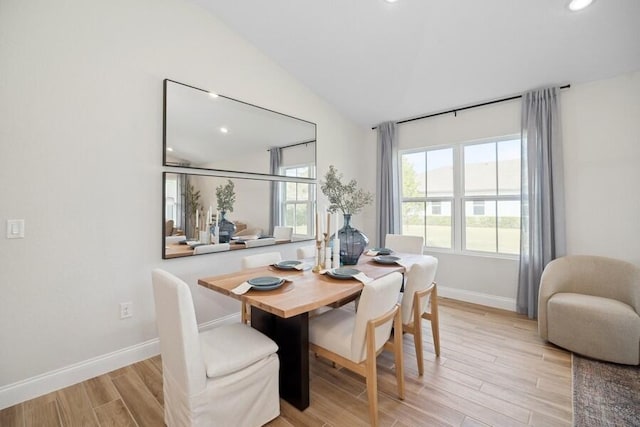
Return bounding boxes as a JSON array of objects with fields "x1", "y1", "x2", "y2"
[{"x1": 280, "y1": 165, "x2": 315, "y2": 237}]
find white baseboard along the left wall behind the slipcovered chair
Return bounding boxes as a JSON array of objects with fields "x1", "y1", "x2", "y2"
[{"x1": 0, "y1": 313, "x2": 240, "y2": 409}]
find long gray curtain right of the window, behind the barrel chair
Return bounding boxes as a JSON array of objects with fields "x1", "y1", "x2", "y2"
[{"x1": 517, "y1": 87, "x2": 565, "y2": 319}]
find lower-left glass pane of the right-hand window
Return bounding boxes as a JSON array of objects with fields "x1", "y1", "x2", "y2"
[{"x1": 464, "y1": 200, "x2": 497, "y2": 252}]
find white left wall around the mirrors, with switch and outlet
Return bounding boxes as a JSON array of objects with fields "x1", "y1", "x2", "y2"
[{"x1": 0, "y1": 0, "x2": 366, "y2": 408}]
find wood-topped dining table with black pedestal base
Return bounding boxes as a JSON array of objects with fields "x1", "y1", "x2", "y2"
[{"x1": 198, "y1": 253, "x2": 422, "y2": 410}]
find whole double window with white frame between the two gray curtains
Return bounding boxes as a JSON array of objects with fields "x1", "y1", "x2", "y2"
[{"x1": 400, "y1": 137, "x2": 521, "y2": 255}]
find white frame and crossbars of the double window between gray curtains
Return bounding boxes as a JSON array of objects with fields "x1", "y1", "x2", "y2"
[{"x1": 397, "y1": 134, "x2": 522, "y2": 259}]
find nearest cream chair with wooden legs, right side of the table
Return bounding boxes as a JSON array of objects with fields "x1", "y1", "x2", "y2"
[{"x1": 309, "y1": 272, "x2": 404, "y2": 426}]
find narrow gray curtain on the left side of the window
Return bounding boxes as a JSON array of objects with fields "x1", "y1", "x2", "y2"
[{"x1": 376, "y1": 122, "x2": 400, "y2": 247}]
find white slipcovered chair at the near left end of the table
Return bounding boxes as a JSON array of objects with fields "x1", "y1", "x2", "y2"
[{"x1": 152, "y1": 269, "x2": 280, "y2": 427}]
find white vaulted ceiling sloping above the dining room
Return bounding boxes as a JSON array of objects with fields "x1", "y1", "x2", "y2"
[{"x1": 193, "y1": 0, "x2": 640, "y2": 126}]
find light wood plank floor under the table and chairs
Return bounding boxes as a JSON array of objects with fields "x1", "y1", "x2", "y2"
[{"x1": 0, "y1": 299, "x2": 572, "y2": 427}]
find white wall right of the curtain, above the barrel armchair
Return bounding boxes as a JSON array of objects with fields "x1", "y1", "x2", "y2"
[{"x1": 562, "y1": 71, "x2": 640, "y2": 265}]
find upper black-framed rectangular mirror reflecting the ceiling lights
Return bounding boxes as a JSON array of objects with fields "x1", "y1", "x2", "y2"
[{"x1": 163, "y1": 79, "x2": 316, "y2": 179}]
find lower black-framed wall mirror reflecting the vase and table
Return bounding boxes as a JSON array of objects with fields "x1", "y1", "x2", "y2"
[{"x1": 162, "y1": 172, "x2": 316, "y2": 259}]
